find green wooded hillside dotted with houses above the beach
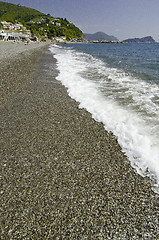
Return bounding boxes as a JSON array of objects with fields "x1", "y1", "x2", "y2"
[{"x1": 0, "y1": 1, "x2": 83, "y2": 40}]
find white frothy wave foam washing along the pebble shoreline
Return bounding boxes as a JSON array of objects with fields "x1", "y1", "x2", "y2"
[{"x1": 50, "y1": 45, "x2": 159, "y2": 191}]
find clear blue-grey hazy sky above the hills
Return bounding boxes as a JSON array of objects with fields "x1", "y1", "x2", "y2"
[{"x1": 3, "y1": 0, "x2": 159, "y2": 42}]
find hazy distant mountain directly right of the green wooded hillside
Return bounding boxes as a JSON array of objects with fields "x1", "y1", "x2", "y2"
[{"x1": 84, "y1": 32, "x2": 119, "y2": 41}]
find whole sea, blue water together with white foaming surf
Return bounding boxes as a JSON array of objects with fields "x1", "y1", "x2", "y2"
[{"x1": 50, "y1": 43, "x2": 159, "y2": 193}]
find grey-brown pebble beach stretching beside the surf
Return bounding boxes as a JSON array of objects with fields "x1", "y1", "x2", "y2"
[{"x1": 0, "y1": 41, "x2": 159, "y2": 240}]
